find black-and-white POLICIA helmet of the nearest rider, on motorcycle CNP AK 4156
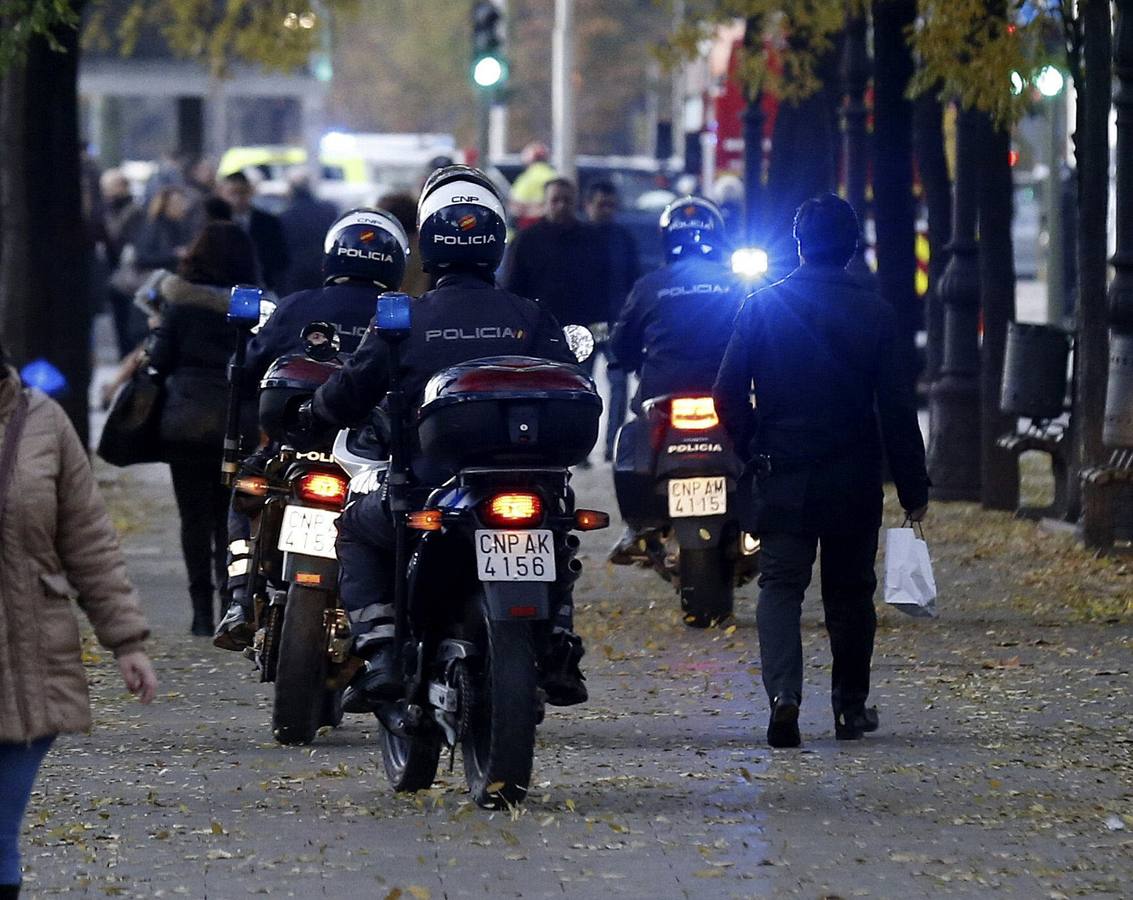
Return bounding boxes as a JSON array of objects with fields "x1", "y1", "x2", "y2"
[{"x1": 417, "y1": 165, "x2": 508, "y2": 274}]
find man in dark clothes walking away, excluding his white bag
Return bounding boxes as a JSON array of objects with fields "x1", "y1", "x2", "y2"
[{"x1": 714, "y1": 194, "x2": 929, "y2": 747}]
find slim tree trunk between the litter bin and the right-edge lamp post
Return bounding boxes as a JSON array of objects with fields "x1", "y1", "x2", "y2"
[{"x1": 1068, "y1": 0, "x2": 1113, "y2": 520}]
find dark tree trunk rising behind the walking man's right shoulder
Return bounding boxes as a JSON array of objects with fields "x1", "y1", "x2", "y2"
[{"x1": 872, "y1": 0, "x2": 922, "y2": 381}]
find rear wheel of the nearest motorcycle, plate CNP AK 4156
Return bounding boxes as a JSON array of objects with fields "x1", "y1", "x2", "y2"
[{"x1": 461, "y1": 612, "x2": 538, "y2": 809}]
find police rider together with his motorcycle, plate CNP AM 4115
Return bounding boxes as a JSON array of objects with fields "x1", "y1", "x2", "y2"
[{"x1": 610, "y1": 196, "x2": 752, "y2": 627}]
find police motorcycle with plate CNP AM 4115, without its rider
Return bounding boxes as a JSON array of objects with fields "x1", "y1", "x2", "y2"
[{"x1": 611, "y1": 394, "x2": 759, "y2": 628}]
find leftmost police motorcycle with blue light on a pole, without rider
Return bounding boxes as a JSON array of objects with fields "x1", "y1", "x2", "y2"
[{"x1": 223, "y1": 288, "x2": 353, "y2": 745}]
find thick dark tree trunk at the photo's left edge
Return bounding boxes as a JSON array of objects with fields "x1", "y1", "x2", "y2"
[{"x1": 0, "y1": 0, "x2": 92, "y2": 443}]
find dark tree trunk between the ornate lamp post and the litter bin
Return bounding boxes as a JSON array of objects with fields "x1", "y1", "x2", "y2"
[{"x1": 978, "y1": 117, "x2": 1019, "y2": 510}]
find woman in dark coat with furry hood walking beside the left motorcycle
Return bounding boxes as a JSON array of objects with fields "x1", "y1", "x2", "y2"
[{"x1": 148, "y1": 222, "x2": 256, "y2": 636}]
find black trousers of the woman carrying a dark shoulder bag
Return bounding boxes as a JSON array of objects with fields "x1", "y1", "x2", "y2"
[{"x1": 169, "y1": 457, "x2": 230, "y2": 614}]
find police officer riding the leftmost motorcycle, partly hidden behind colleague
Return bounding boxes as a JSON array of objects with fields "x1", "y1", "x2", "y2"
[{"x1": 213, "y1": 209, "x2": 409, "y2": 651}]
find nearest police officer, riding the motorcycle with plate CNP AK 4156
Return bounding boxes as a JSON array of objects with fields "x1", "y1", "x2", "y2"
[{"x1": 296, "y1": 165, "x2": 587, "y2": 712}]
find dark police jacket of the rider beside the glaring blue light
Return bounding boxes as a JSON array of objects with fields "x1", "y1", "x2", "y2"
[{"x1": 610, "y1": 258, "x2": 744, "y2": 400}]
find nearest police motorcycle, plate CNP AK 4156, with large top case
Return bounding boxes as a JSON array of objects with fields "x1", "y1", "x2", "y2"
[{"x1": 334, "y1": 294, "x2": 610, "y2": 808}]
